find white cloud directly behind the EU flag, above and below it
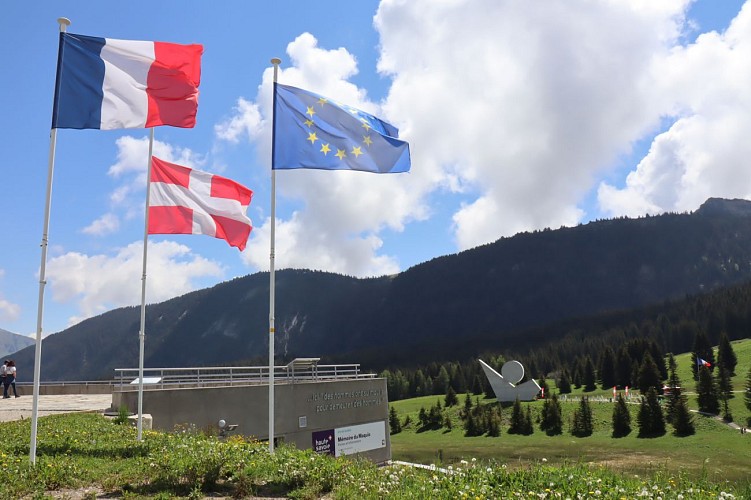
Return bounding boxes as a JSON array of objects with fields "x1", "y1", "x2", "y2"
[{"x1": 215, "y1": 33, "x2": 432, "y2": 276}]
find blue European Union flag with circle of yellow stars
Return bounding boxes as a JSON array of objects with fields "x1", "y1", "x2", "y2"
[{"x1": 271, "y1": 83, "x2": 410, "y2": 174}]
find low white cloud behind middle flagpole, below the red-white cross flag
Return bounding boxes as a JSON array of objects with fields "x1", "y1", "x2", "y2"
[{"x1": 47, "y1": 241, "x2": 223, "y2": 324}]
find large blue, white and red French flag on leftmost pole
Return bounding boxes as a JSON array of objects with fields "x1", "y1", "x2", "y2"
[{"x1": 52, "y1": 33, "x2": 203, "y2": 130}]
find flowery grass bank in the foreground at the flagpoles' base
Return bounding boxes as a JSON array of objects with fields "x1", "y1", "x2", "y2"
[{"x1": 0, "y1": 414, "x2": 751, "y2": 499}]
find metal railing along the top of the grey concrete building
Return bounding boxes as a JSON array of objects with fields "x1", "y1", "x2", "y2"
[{"x1": 115, "y1": 364, "x2": 376, "y2": 391}]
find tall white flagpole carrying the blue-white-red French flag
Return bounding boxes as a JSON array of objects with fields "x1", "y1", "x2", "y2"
[{"x1": 29, "y1": 17, "x2": 70, "y2": 464}]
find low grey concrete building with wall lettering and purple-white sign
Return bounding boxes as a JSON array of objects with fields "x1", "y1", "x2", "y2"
[{"x1": 112, "y1": 377, "x2": 391, "y2": 463}]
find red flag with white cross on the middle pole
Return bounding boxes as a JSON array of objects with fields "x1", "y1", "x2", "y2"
[{"x1": 148, "y1": 156, "x2": 253, "y2": 251}]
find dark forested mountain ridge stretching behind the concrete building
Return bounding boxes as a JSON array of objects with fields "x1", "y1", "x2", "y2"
[{"x1": 11, "y1": 199, "x2": 751, "y2": 380}]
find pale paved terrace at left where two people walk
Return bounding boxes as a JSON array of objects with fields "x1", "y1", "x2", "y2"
[{"x1": 0, "y1": 394, "x2": 112, "y2": 422}]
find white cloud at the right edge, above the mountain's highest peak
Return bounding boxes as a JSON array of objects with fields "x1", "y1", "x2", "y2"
[{"x1": 598, "y1": 2, "x2": 751, "y2": 215}]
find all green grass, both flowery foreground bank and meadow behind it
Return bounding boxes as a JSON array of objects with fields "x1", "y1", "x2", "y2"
[{"x1": 0, "y1": 340, "x2": 751, "y2": 500}]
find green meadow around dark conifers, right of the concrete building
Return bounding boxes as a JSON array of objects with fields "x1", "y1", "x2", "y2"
[{"x1": 391, "y1": 339, "x2": 751, "y2": 482}]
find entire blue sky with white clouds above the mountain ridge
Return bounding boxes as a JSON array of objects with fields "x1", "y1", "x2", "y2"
[{"x1": 0, "y1": 0, "x2": 751, "y2": 335}]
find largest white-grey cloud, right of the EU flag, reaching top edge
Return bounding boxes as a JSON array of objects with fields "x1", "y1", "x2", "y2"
[{"x1": 375, "y1": 0, "x2": 700, "y2": 248}]
